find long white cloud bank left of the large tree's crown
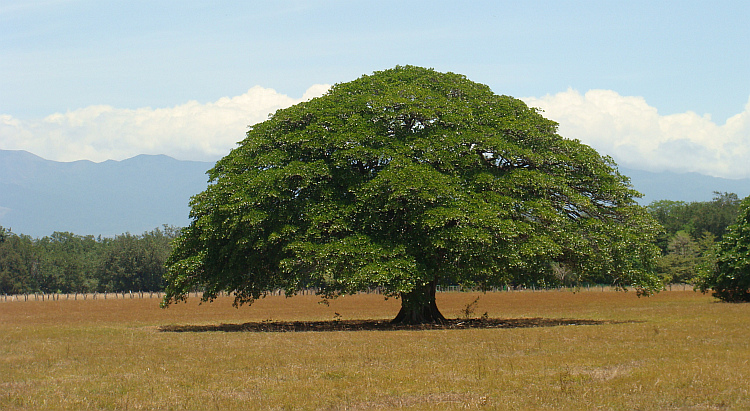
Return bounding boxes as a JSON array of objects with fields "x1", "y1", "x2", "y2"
[{"x1": 0, "y1": 84, "x2": 330, "y2": 161}]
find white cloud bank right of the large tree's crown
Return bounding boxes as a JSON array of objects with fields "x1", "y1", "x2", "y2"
[{"x1": 523, "y1": 90, "x2": 750, "y2": 178}]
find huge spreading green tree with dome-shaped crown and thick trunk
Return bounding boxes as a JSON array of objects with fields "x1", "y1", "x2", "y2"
[{"x1": 163, "y1": 66, "x2": 658, "y2": 323}]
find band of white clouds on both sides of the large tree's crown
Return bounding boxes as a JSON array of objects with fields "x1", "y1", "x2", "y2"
[{"x1": 0, "y1": 85, "x2": 750, "y2": 178}]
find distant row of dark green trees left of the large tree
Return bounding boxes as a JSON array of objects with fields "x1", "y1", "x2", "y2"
[{"x1": 0, "y1": 226, "x2": 179, "y2": 294}]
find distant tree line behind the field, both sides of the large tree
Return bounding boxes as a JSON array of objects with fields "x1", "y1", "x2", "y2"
[{"x1": 0, "y1": 192, "x2": 740, "y2": 294}]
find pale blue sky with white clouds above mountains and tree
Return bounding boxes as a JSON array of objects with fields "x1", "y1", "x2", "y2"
[{"x1": 0, "y1": 0, "x2": 750, "y2": 177}]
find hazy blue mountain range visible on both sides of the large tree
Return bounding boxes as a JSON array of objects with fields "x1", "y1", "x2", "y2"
[{"x1": 0, "y1": 150, "x2": 750, "y2": 237}]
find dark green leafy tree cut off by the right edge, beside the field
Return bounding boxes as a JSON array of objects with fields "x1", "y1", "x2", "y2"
[{"x1": 696, "y1": 196, "x2": 750, "y2": 302}]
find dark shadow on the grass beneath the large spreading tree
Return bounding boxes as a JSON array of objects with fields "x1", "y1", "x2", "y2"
[{"x1": 158, "y1": 318, "x2": 641, "y2": 332}]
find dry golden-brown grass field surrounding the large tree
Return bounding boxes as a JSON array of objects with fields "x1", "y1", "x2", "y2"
[{"x1": 0, "y1": 291, "x2": 750, "y2": 410}]
